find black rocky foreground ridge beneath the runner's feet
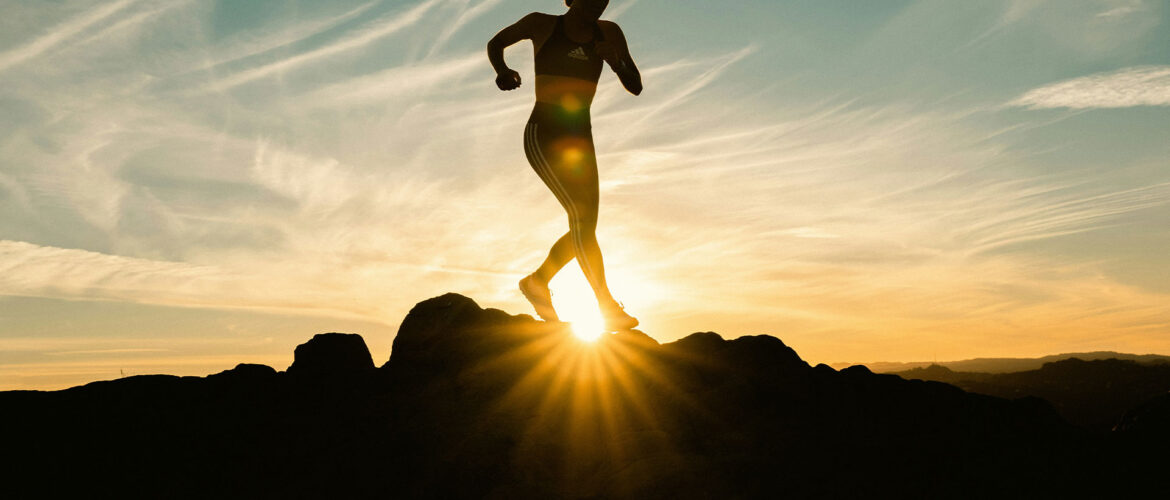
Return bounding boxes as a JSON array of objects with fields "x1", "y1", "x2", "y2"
[{"x1": 0, "y1": 294, "x2": 1170, "y2": 499}]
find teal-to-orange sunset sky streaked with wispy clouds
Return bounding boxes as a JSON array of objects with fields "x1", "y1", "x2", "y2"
[{"x1": 0, "y1": 0, "x2": 1170, "y2": 390}]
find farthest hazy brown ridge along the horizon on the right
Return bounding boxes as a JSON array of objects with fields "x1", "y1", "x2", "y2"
[{"x1": 831, "y1": 351, "x2": 1170, "y2": 374}]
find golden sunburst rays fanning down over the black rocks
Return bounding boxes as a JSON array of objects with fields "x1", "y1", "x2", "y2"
[{"x1": 470, "y1": 323, "x2": 711, "y2": 495}]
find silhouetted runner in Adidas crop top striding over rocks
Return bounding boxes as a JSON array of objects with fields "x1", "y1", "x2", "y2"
[{"x1": 488, "y1": 0, "x2": 642, "y2": 331}]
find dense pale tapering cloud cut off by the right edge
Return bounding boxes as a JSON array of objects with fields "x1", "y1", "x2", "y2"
[{"x1": 1009, "y1": 66, "x2": 1170, "y2": 109}]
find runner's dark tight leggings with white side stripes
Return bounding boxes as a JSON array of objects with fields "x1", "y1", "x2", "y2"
[{"x1": 524, "y1": 102, "x2": 613, "y2": 303}]
